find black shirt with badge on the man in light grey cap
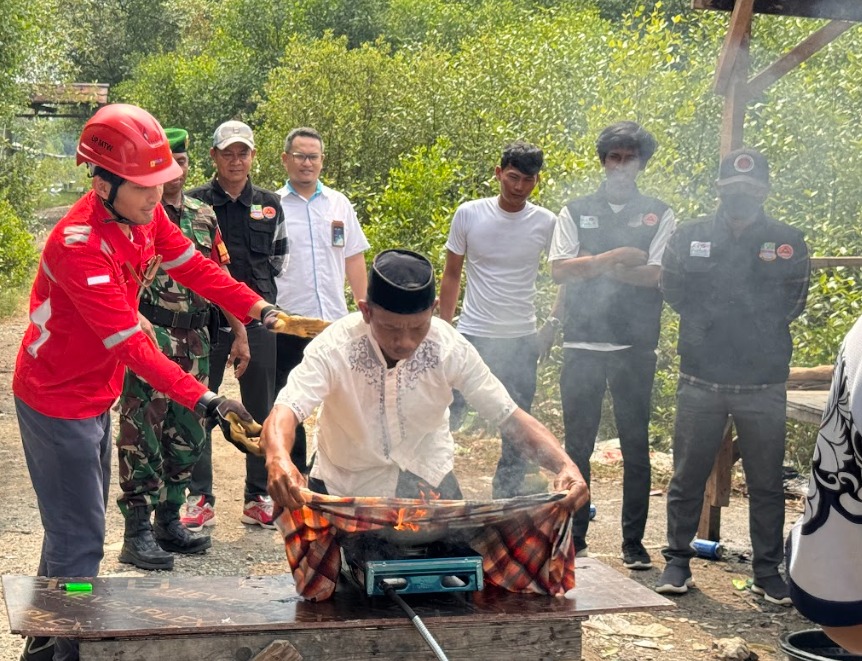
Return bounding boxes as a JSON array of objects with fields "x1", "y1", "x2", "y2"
[{"x1": 186, "y1": 179, "x2": 281, "y2": 303}]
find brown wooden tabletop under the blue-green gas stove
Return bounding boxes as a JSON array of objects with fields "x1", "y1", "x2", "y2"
[{"x1": 3, "y1": 558, "x2": 674, "y2": 640}]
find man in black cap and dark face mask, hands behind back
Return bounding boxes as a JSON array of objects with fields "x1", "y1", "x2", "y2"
[{"x1": 656, "y1": 149, "x2": 809, "y2": 605}]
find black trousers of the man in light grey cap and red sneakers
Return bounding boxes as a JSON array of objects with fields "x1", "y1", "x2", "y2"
[{"x1": 189, "y1": 322, "x2": 275, "y2": 504}]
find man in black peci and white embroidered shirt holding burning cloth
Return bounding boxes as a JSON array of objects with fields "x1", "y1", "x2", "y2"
[{"x1": 262, "y1": 250, "x2": 588, "y2": 510}]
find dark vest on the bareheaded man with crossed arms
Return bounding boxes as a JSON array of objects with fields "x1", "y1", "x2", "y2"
[{"x1": 563, "y1": 185, "x2": 668, "y2": 349}]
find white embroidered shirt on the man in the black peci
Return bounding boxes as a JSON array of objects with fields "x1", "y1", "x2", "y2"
[{"x1": 276, "y1": 312, "x2": 517, "y2": 497}]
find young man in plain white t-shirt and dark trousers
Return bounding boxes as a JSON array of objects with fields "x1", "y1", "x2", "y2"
[{"x1": 440, "y1": 141, "x2": 556, "y2": 498}]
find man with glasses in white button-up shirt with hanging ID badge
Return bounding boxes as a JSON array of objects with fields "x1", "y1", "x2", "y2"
[{"x1": 275, "y1": 127, "x2": 368, "y2": 473}]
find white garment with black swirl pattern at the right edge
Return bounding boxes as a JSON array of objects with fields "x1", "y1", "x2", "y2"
[{"x1": 788, "y1": 320, "x2": 862, "y2": 626}]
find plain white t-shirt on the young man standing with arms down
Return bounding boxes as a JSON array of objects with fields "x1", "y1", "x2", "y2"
[{"x1": 446, "y1": 197, "x2": 556, "y2": 338}]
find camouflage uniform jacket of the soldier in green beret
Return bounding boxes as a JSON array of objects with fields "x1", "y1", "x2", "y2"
[{"x1": 141, "y1": 195, "x2": 230, "y2": 358}]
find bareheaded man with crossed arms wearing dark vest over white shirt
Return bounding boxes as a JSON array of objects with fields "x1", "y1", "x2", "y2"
[{"x1": 548, "y1": 122, "x2": 674, "y2": 569}]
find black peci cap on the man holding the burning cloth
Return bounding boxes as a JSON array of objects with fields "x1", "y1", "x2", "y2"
[{"x1": 368, "y1": 249, "x2": 437, "y2": 314}]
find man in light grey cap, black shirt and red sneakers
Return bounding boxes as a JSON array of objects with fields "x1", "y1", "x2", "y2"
[{"x1": 183, "y1": 120, "x2": 287, "y2": 529}]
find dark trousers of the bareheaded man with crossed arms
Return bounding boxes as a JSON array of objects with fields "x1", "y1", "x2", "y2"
[{"x1": 560, "y1": 347, "x2": 656, "y2": 548}]
